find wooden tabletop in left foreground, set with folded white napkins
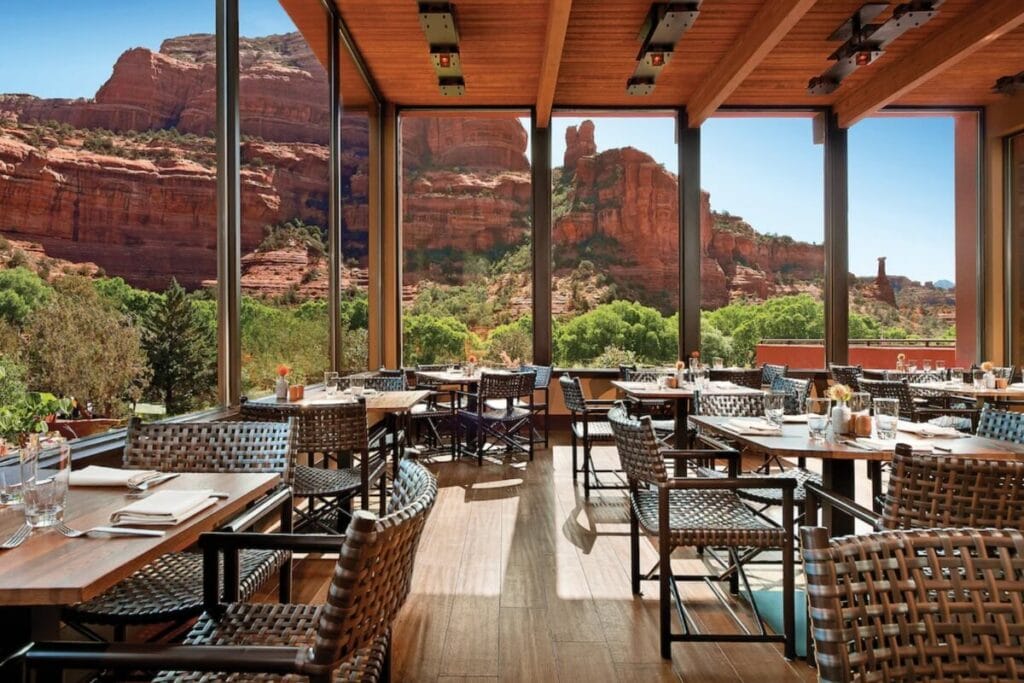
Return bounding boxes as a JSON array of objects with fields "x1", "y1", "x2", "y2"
[{"x1": 0, "y1": 472, "x2": 281, "y2": 605}]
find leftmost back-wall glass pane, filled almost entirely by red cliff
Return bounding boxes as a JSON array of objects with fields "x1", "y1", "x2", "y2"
[{"x1": 400, "y1": 114, "x2": 532, "y2": 366}]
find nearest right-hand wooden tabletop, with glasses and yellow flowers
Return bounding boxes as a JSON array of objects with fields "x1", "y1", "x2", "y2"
[{"x1": 690, "y1": 416, "x2": 1024, "y2": 461}]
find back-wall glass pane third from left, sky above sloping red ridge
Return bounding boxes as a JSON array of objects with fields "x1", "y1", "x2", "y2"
[{"x1": 700, "y1": 117, "x2": 824, "y2": 369}]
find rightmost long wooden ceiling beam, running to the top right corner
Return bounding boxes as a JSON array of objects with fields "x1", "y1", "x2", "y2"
[{"x1": 835, "y1": 0, "x2": 1024, "y2": 128}]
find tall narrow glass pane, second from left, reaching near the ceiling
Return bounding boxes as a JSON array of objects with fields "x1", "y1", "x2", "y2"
[{"x1": 239, "y1": 0, "x2": 330, "y2": 396}]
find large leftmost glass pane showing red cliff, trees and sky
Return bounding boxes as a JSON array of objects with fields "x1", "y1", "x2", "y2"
[{"x1": 0, "y1": 0, "x2": 217, "y2": 428}]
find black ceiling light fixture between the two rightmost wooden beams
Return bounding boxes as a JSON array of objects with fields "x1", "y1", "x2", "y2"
[{"x1": 807, "y1": 0, "x2": 945, "y2": 95}]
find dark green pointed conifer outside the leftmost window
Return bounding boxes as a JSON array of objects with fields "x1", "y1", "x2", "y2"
[{"x1": 142, "y1": 280, "x2": 217, "y2": 415}]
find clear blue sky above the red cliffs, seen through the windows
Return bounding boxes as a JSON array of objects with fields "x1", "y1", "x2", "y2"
[{"x1": 0, "y1": 0, "x2": 954, "y2": 281}]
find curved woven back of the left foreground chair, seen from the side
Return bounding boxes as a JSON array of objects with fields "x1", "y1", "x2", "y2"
[{"x1": 306, "y1": 460, "x2": 437, "y2": 674}]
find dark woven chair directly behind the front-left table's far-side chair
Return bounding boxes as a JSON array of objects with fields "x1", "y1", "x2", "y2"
[{"x1": 241, "y1": 398, "x2": 387, "y2": 532}]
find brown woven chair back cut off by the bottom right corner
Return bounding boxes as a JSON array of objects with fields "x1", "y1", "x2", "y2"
[{"x1": 801, "y1": 526, "x2": 1024, "y2": 682}]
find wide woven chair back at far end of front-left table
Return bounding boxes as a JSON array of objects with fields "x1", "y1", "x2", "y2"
[{"x1": 121, "y1": 418, "x2": 295, "y2": 473}]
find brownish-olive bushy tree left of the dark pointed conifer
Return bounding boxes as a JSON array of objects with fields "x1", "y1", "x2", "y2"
[{"x1": 25, "y1": 275, "x2": 150, "y2": 417}]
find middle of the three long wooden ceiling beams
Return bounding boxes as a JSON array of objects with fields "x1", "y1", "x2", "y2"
[{"x1": 686, "y1": 0, "x2": 816, "y2": 128}]
